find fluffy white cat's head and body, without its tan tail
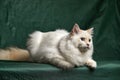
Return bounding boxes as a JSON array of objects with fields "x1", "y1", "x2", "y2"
[{"x1": 28, "y1": 24, "x2": 97, "y2": 69}]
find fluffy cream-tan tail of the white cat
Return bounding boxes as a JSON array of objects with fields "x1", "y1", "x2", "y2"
[{"x1": 0, "y1": 47, "x2": 30, "y2": 61}]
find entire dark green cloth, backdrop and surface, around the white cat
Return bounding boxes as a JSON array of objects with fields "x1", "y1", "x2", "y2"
[{"x1": 0, "y1": 0, "x2": 120, "y2": 80}]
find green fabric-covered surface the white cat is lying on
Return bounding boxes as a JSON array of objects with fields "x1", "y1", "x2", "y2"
[{"x1": 0, "y1": 61, "x2": 120, "y2": 80}]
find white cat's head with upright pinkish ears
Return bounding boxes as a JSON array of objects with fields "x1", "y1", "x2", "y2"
[{"x1": 69, "y1": 24, "x2": 93, "y2": 52}]
